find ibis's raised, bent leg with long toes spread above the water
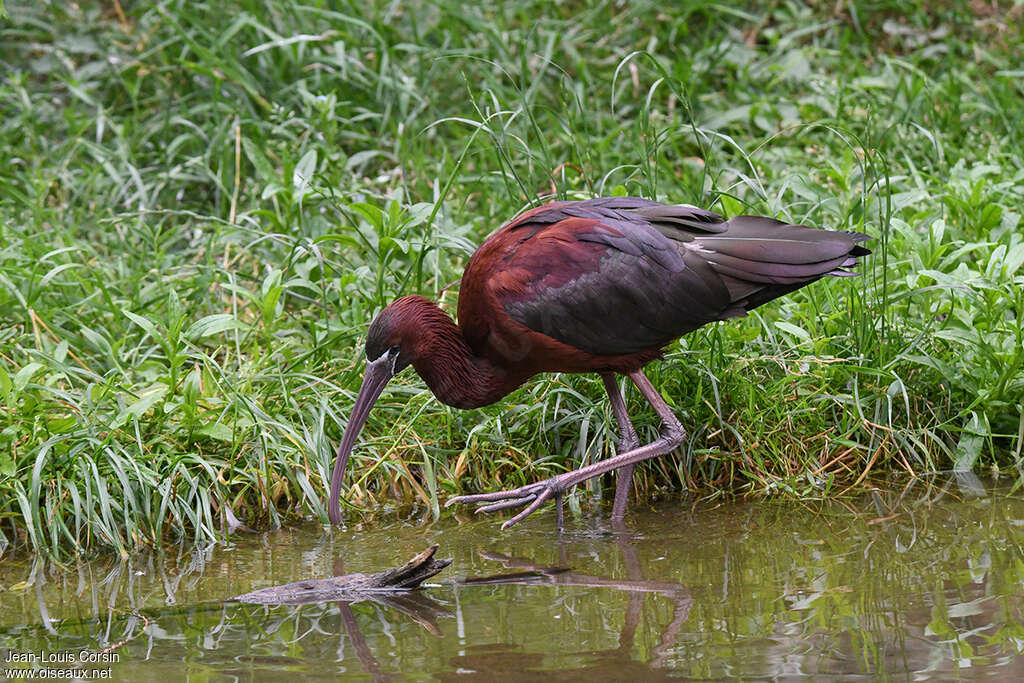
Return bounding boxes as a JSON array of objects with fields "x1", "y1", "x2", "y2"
[{"x1": 445, "y1": 370, "x2": 686, "y2": 528}]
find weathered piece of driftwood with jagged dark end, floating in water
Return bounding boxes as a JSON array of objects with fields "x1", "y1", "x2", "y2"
[{"x1": 237, "y1": 544, "x2": 452, "y2": 605}]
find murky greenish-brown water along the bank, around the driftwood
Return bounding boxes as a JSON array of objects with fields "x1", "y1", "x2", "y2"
[{"x1": 0, "y1": 478, "x2": 1024, "y2": 682}]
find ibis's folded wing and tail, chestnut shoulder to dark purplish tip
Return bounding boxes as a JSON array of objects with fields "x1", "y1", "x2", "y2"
[{"x1": 483, "y1": 197, "x2": 870, "y2": 355}]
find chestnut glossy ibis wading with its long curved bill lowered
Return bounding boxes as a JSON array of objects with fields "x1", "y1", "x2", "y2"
[{"x1": 328, "y1": 197, "x2": 870, "y2": 527}]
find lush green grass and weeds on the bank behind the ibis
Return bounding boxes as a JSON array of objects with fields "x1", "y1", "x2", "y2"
[{"x1": 0, "y1": 0, "x2": 1024, "y2": 555}]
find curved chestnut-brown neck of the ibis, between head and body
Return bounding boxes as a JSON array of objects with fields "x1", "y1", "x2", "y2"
[{"x1": 413, "y1": 304, "x2": 522, "y2": 409}]
